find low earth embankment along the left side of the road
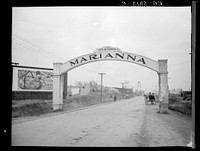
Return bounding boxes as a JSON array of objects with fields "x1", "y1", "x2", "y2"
[{"x1": 12, "y1": 92, "x2": 129, "y2": 118}]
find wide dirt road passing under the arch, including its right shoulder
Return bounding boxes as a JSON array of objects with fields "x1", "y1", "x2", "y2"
[{"x1": 12, "y1": 96, "x2": 192, "y2": 147}]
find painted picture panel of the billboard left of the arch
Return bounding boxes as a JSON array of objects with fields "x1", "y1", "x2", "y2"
[{"x1": 17, "y1": 69, "x2": 53, "y2": 90}]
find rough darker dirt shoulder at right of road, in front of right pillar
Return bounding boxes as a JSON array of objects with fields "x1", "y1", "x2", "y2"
[{"x1": 134, "y1": 106, "x2": 190, "y2": 147}]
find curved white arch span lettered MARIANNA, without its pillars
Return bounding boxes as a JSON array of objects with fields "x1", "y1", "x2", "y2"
[{"x1": 60, "y1": 46, "x2": 158, "y2": 74}]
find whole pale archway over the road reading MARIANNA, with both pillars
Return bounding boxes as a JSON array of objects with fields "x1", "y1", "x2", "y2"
[{"x1": 53, "y1": 47, "x2": 168, "y2": 113}]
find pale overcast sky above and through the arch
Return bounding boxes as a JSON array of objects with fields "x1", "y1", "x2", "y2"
[{"x1": 11, "y1": 7, "x2": 191, "y2": 91}]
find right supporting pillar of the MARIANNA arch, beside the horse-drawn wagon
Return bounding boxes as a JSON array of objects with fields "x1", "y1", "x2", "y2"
[{"x1": 158, "y1": 59, "x2": 169, "y2": 113}]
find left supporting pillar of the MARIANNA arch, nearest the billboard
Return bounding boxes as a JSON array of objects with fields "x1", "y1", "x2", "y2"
[{"x1": 53, "y1": 63, "x2": 64, "y2": 111}]
